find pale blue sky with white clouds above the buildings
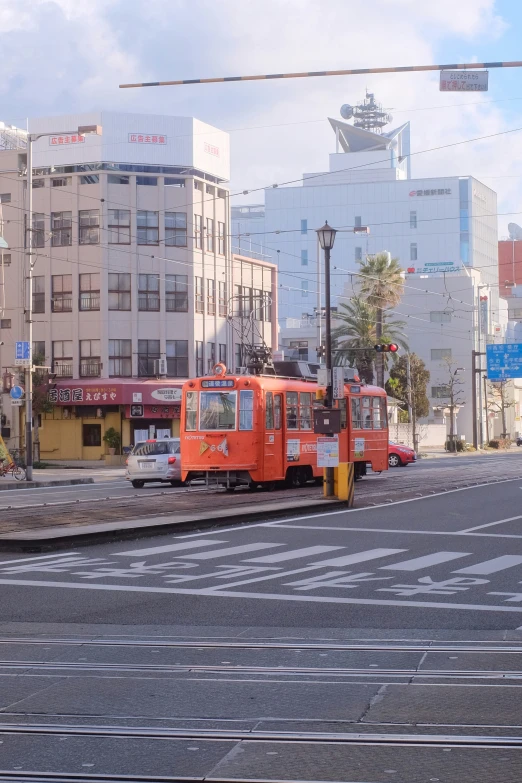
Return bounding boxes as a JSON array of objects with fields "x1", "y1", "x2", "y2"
[{"x1": 0, "y1": 0, "x2": 522, "y2": 236}]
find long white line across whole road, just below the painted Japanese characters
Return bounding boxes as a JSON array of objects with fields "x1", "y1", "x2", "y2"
[{"x1": 0, "y1": 580, "x2": 522, "y2": 616}]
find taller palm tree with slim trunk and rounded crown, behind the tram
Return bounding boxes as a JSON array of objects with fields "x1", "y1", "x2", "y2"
[{"x1": 360, "y1": 253, "x2": 404, "y2": 386}]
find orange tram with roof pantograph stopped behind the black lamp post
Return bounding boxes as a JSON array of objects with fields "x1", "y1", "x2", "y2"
[{"x1": 181, "y1": 364, "x2": 388, "y2": 489}]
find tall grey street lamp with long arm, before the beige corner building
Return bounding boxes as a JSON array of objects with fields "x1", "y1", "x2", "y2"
[{"x1": 25, "y1": 125, "x2": 102, "y2": 481}]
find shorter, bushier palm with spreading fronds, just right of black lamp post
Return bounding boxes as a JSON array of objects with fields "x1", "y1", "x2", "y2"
[{"x1": 332, "y1": 296, "x2": 408, "y2": 384}]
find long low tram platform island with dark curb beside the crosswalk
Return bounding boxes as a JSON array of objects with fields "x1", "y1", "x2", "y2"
[{"x1": 0, "y1": 499, "x2": 347, "y2": 552}]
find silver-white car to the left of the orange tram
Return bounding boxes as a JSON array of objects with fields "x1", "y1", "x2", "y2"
[{"x1": 125, "y1": 438, "x2": 182, "y2": 488}]
